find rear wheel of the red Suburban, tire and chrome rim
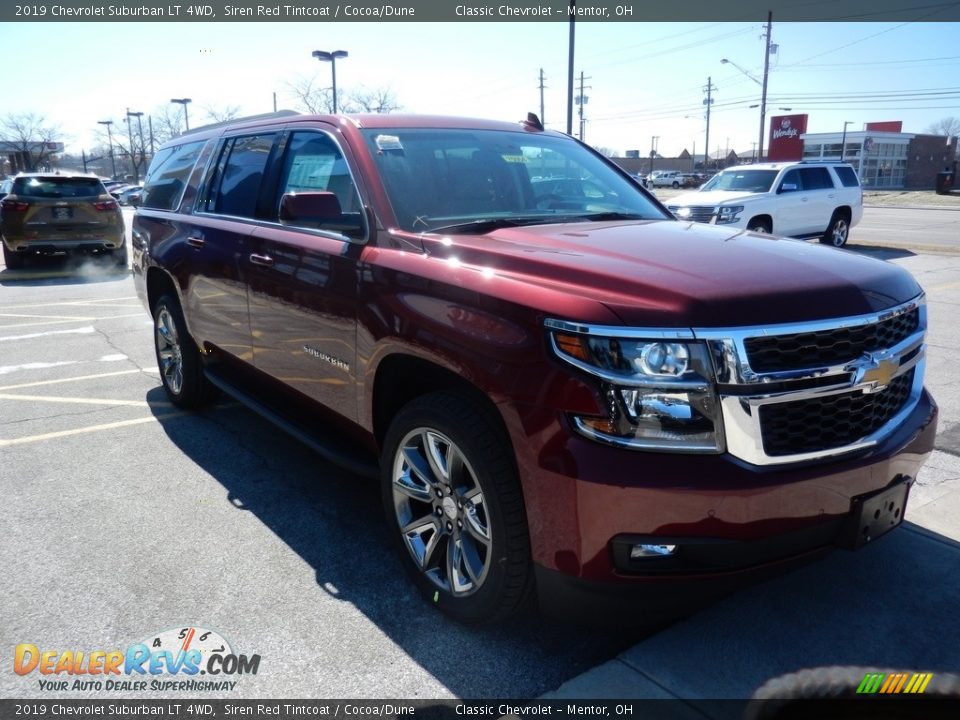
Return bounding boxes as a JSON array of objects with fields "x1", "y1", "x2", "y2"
[{"x1": 153, "y1": 295, "x2": 217, "y2": 409}]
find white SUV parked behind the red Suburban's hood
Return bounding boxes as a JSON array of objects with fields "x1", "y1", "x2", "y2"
[{"x1": 667, "y1": 162, "x2": 863, "y2": 247}]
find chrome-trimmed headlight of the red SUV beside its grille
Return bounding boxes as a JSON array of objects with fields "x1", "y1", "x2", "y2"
[{"x1": 546, "y1": 320, "x2": 724, "y2": 452}]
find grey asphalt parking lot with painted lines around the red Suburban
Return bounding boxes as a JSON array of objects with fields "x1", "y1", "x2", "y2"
[{"x1": 0, "y1": 207, "x2": 960, "y2": 704}]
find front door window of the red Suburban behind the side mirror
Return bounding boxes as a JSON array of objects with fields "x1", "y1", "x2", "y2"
[{"x1": 272, "y1": 132, "x2": 362, "y2": 237}]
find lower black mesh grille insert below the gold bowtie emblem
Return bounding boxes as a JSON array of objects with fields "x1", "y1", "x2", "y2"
[{"x1": 760, "y1": 370, "x2": 914, "y2": 457}]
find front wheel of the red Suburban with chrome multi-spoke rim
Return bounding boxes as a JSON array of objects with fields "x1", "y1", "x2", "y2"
[{"x1": 381, "y1": 392, "x2": 533, "y2": 624}]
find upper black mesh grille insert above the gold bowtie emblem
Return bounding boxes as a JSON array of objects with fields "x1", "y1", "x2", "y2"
[{"x1": 744, "y1": 308, "x2": 920, "y2": 373}]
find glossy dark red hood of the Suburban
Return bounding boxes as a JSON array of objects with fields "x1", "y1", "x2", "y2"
[{"x1": 421, "y1": 220, "x2": 921, "y2": 328}]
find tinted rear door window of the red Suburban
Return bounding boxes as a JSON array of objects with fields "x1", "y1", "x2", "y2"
[{"x1": 205, "y1": 134, "x2": 276, "y2": 218}]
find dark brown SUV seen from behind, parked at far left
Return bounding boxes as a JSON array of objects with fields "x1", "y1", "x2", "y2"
[{"x1": 0, "y1": 173, "x2": 127, "y2": 268}]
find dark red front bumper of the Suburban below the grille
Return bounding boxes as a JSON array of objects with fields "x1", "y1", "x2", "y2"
[{"x1": 524, "y1": 390, "x2": 937, "y2": 606}]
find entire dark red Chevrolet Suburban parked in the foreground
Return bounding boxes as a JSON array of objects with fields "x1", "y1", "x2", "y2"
[{"x1": 133, "y1": 115, "x2": 937, "y2": 622}]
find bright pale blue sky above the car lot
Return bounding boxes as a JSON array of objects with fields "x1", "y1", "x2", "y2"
[{"x1": 0, "y1": 18, "x2": 960, "y2": 156}]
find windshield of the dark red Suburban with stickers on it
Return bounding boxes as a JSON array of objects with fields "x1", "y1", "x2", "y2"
[{"x1": 364, "y1": 128, "x2": 669, "y2": 232}]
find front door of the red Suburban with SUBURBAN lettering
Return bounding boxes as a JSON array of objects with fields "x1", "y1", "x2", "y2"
[{"x1": 247, "y1": 129, "x2": 366, "y2": 420}]
